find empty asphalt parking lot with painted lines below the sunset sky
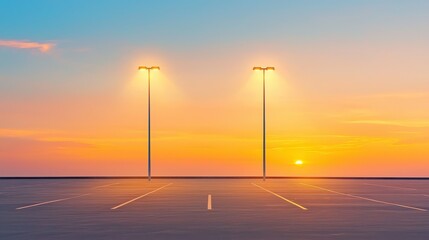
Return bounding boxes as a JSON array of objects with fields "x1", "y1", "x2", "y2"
[{"x1": 0, "y1": 179, "x2": 429, "y2": 240}]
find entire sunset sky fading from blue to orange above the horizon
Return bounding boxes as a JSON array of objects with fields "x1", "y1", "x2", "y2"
[{"x1": 0, "y1": 0, "x2": 429, "y2": 176}]
